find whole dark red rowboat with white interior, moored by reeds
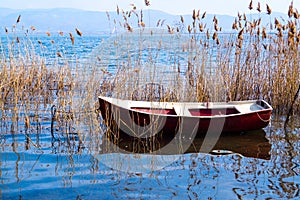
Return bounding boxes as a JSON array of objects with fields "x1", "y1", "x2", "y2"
[{"x1": 99, "y1": 96, "x2": 272, "y2": 138}]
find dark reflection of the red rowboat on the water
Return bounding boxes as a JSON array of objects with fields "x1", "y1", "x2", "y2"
[{"x1": 101, "y1": 129, "x2": 271, "y2": 160}]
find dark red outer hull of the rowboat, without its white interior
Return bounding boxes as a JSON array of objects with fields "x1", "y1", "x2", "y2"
[{"x1": 99, "y1": 97, "x2": 272, "y2": 138}]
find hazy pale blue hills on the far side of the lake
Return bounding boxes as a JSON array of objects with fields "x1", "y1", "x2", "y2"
[{"x1": 0, "y1": 8, "x2": 286, "y2": 34}]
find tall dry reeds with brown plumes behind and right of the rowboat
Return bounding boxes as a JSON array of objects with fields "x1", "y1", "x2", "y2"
[{"x1": 102, "y1": 1, "x2": 300, "y2": 115}]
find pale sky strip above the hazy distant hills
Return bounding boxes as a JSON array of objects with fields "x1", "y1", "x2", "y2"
[{"x1": 0, "y1": 0, "x2": 300, "y2": 16}]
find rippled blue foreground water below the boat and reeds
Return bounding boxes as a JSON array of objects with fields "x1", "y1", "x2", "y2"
[{"x1": 0, "y1": 130, "x2": 300, "y2": 199}]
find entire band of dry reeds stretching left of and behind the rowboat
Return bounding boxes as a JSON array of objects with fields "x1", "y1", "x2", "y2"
[{"x1": 0, "y1": 1, "x2": 300, "y2": 153}]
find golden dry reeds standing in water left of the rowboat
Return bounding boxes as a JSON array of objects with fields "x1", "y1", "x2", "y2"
[{"x1": 0, "y1": 22, "x2": 104, "y2": 146}]
